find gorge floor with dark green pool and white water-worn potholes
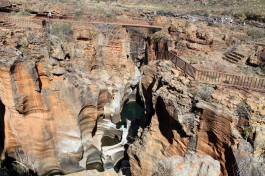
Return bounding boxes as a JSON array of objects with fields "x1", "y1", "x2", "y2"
[{"x1": 94, "y1": 88, "x2": 145, "y2": 175}]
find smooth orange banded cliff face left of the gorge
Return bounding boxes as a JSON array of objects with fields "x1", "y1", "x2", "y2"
[{"x1": 0, "y1": 23, "x2": 140, "y2": 175}]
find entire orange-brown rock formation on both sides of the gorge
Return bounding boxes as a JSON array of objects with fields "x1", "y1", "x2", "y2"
[{"x1": 0, "y1": 0, "x2": 265, "y2": 176}]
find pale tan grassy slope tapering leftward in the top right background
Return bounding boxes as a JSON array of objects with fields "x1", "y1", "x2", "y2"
[{"x1": 116, "y1": 0, "x2": 265, "y2": 19}]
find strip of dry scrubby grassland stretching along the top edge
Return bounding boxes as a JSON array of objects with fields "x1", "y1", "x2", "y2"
[{"x1": 11, "y1": 0, "x2": 265, "y2": 22}]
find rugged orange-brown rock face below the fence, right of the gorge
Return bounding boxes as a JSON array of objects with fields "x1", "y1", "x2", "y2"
[{"x1": 128, "y1": 61, "x2": 264, "y2": 175}]
